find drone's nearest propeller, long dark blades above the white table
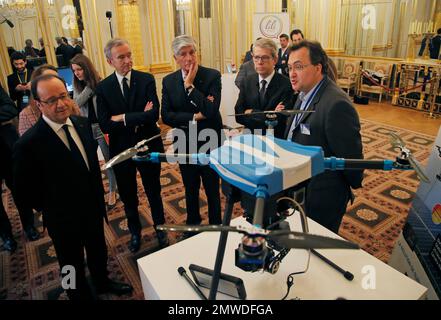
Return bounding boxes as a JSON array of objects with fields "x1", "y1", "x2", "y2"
[{"x1": 157, "y1": 225, "x2": 359, "y2": 249}]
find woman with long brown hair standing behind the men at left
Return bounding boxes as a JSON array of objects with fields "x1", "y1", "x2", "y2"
[{"x1": 71, "y1": 54, "x2": 116, "y2": 206}]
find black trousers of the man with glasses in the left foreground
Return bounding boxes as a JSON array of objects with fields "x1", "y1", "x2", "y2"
[{"x1": 48, "y1": 210, "x2": 108, "y2": 300}]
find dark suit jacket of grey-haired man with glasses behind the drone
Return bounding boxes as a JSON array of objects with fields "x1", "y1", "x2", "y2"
[{"x1": 234, "y1": 73, "x2": 292, "y2": 138}]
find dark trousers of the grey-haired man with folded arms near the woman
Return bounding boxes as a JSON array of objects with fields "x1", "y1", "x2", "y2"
[{"x1": 114, "y1": 161, "x2": 165, "y2": 235}]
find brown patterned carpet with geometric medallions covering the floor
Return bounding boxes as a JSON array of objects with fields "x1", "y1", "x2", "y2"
[{"x1": 0, "y1": 121, "x2": 434, "y2": 300}]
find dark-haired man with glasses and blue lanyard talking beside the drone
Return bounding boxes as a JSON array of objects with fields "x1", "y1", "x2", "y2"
[{"x1": 285, "y1": 41, "x2": 363, "y2": 232}]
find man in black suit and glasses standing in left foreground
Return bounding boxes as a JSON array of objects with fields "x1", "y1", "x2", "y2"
[{"x1": 13, "y1": 75, "x2": 132, "y2": 300}]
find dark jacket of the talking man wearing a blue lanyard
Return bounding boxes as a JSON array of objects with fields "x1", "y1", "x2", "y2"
[{"x1": 285, "y1": 77, "x2": 363, "y2": 191}]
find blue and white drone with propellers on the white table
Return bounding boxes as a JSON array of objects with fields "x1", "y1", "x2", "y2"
[{"x1": 104, "y1": 129, "x2": 429, "y2": 299}]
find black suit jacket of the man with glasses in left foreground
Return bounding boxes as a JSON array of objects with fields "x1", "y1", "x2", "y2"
[{"x1": 13, "y1": 116, "x2": 106, "y2": 236}]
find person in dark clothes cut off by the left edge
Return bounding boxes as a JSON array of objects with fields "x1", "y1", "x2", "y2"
[{"x1": 0, "y1": 86, "x2": 40, "y2": 252}]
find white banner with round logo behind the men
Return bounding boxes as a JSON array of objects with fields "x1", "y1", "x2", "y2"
[{"x1": 253, "y1": 13, "x2": 290, "y2": 43}]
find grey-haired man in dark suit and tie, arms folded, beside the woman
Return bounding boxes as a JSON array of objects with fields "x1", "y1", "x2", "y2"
[{"x1": 96, "y1": 39, "x2": 168, "y2": 252}]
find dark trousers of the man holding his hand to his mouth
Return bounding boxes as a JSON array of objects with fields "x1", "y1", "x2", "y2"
[{"x1": 179, "y1": 164, "x2": 222, "y2": 225}]
